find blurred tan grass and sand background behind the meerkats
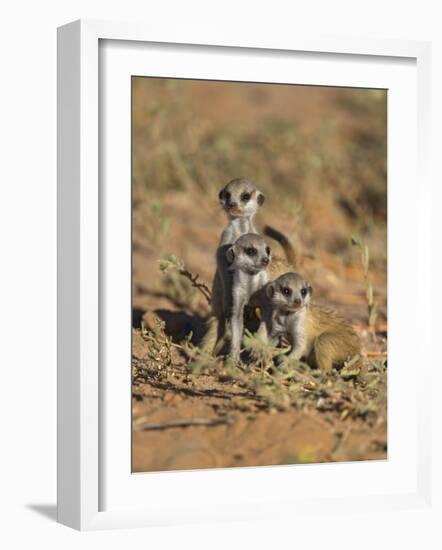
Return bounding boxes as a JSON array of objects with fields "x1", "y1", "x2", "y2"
[{"x1": 132, "y1": 77, "x2": 387, "y2": 337}]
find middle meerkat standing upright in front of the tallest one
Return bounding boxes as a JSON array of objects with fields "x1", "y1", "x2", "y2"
[{"x1": 215, "y1": 233, "x2": 271, "y2": 359}]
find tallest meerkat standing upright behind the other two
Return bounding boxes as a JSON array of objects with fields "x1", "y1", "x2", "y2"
[{"x1": 201, "y1": 178, "x2": 264, "y2": 351}]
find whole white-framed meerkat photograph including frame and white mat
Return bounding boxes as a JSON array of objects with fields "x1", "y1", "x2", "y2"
[{"x1": 58, "y1": 21, "x2": 431, "y2": 530}]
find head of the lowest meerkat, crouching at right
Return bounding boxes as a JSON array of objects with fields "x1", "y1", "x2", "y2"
[{"x1": 266, "y1": 273, "x2": 313, "y2": 313}]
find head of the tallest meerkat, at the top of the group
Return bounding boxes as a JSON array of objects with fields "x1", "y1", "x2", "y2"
[{"x1": 218, "y1": 178, "x2": 264, "y2": 218}]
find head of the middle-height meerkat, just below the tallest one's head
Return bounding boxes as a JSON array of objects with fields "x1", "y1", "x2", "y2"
[{"x1": 226, "y1": 233, "x2": 272, "y2": 275}]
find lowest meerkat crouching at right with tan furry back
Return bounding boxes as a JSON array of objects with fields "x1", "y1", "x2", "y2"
[{"x1": 258, "y1": 273, "x2": 361, "y2": 371}]
